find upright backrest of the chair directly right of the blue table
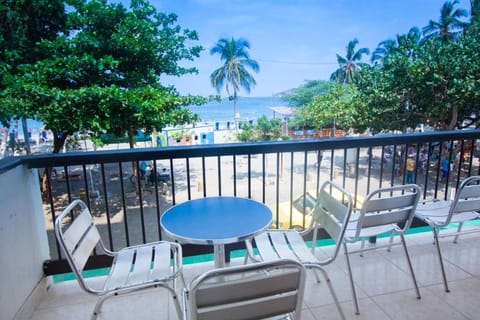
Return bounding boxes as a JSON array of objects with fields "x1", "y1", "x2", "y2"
[{"x1": 312, "y1": 181, "x2": 352, "y2": 259}]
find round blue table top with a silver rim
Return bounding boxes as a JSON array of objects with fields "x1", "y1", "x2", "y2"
[{"x1": 160, "y1": 196, "x2": 272, "y2": 245}]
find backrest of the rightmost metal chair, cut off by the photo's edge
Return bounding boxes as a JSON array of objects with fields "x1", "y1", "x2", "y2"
[{"x1": 447, "y1": 176, "x2": 480, "y2": 220}]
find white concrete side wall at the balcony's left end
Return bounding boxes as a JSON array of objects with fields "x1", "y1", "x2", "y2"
[{"x1": 0, "y1": 165, "x2": 49, "y2": 319}]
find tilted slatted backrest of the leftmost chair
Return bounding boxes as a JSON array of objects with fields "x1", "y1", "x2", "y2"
[{"x1": 55, "y1": 200, "x2": 103, "y2": 291}]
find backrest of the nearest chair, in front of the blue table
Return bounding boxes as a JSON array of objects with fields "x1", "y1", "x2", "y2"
[{"x1": 184, "y1": 259, "x2": 306, "y2": 320}]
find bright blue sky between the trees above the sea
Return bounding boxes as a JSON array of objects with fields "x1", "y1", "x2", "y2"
[{"x1": 127, "y1": 0, "x2": 470, "y2": 97}]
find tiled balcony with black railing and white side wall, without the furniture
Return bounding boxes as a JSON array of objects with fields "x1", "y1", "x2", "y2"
[{"x1": 0, "y1": 130, "x2": 480, "y2": 319}]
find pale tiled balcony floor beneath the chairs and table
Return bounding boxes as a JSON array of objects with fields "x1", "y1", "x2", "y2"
[{"x1": 31, "y1": 226, "x2": 480, "y2": 320}]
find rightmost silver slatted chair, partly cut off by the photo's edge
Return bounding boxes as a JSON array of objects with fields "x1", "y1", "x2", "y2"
[{"x1": 416, "y1": 176, "x2": 480, "y2": 292}]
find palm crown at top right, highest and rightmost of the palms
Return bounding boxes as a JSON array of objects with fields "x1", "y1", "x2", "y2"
[{"x1": 423, "y1": 0, "x2": 468, "y2": 41}]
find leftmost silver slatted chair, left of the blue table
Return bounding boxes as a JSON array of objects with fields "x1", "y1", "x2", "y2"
[{"x1": 55, "y1": 200, "x2": 183, "y2": 319}]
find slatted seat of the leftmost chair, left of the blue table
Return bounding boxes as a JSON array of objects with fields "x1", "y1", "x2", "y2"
[{"x1": 105, "y1": 242, "x2": 174, "y2": 290}]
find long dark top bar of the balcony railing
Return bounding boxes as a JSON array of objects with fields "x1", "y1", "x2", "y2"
[{"x1": 15, "y1": 130, "x2": 480, "y2": 168}]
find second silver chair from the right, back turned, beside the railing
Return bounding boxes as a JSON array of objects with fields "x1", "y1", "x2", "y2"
[{"x1": 344, "y1": 184, "x2": 421, "y2": 314}]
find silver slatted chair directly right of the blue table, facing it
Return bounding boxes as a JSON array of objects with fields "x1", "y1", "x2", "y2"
[{"x1": 246, "y1": 181, "x2": 352, "y2": 319}]
